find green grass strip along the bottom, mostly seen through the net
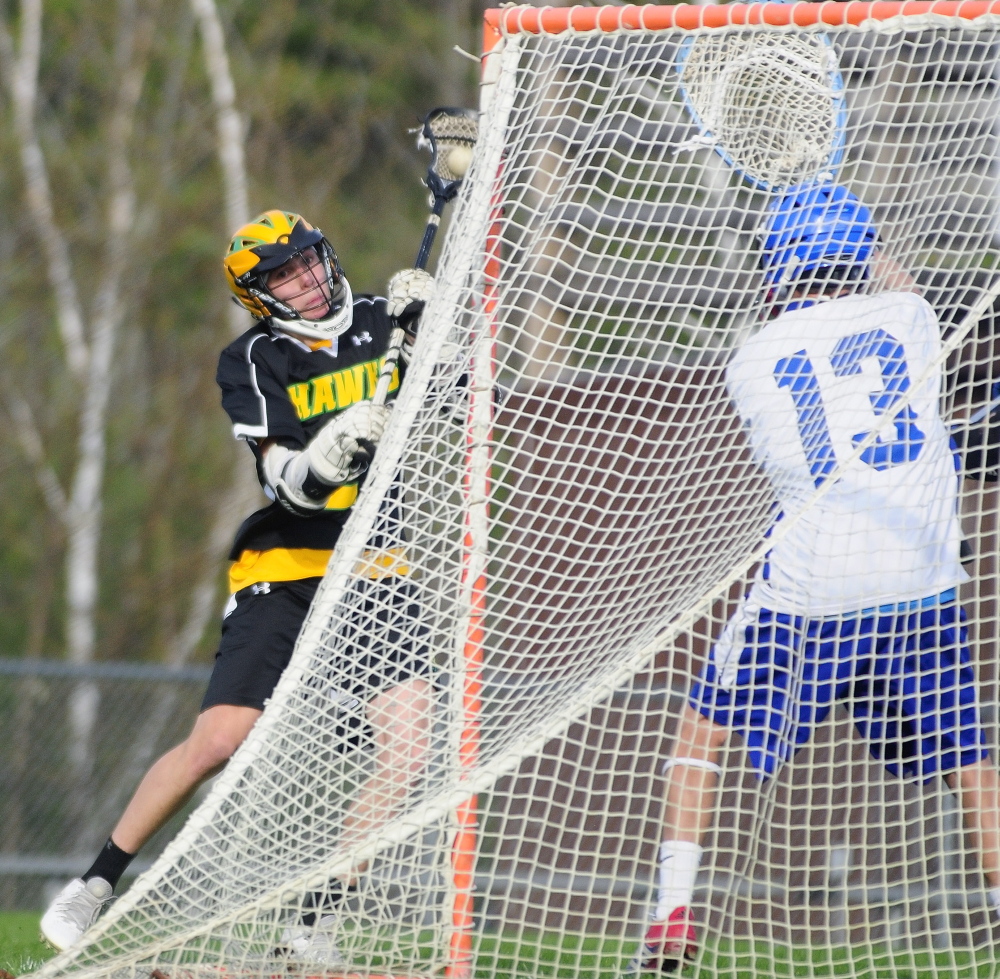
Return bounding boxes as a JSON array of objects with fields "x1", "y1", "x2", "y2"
[{"x1": 0, "y1": 912, "x2": 1000, "y2": 979}]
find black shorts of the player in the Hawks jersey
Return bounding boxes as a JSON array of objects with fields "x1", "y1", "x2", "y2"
[{"x1": 201, "y1": 578, "x2": 430, "y2": 711}]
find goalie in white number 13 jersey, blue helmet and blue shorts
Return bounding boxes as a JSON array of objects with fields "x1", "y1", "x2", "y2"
[{"x1": 632, "y1": 183, "x2": 1000, "y2": 971}]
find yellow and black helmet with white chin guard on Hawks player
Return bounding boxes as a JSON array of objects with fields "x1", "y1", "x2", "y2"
[{"x1": 222, "y1": 210, "x2": 353, "y2": 340}]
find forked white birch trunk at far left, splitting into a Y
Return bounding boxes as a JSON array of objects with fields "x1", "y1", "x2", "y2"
[{"x1": 0, "y1": 0, "x2": 151, "y2": 840}]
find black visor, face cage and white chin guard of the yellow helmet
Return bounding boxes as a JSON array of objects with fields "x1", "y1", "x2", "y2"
[{"x1": 235, "y1": 221, "x2": 354, "y2": 340}]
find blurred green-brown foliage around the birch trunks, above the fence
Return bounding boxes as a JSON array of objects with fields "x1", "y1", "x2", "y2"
[{"x1": 0, "y1": 0, "x2": 484, "y2": 661}]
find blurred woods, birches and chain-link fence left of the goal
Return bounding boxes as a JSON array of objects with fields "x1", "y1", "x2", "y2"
[{"x1": 0, "y1": 0, "x2": 496, "y2": 907}]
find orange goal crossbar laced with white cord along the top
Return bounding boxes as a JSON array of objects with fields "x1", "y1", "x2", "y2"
[{"x1": 485, "y1": 0, "x2": 1000, "y2": 43}]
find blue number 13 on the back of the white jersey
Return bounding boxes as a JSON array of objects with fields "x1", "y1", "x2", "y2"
[{"x1": 774, "y1": 330, "x2": 925, "y2": 486}]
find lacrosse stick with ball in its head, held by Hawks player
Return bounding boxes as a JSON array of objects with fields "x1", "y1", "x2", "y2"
[{"x1": 354, "y1": 108, "x2": 479, "y2": 468}]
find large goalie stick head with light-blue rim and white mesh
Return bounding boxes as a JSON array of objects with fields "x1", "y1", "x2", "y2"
[{"x1": 676, "y1": 30, "x2": 847, "y2": 191}]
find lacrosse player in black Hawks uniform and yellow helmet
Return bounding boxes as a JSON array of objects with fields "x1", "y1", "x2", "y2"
[{"x1": 42, "y1": 210, "x2": 434, "y2": 966}]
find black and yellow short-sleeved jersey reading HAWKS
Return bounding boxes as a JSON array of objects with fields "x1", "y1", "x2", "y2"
[{"x1": 216, "y1": 296, "x2": 400, "y2": 591}]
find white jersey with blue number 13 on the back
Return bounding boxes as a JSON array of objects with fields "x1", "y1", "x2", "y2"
[{"x1": 727, "y1": 292, "x2": 967, "y2": 617}]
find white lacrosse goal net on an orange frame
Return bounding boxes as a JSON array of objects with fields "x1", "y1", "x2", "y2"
[{"x1": 38, "y1": 3, "x2": 1000, "y2": 979}]
